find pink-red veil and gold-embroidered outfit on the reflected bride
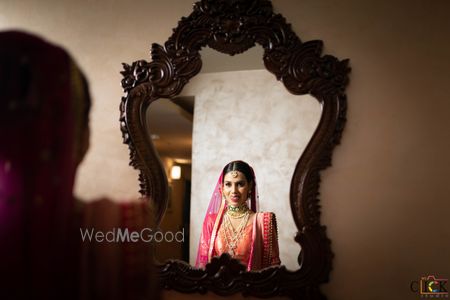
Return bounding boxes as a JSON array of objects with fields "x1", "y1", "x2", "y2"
[{"x1": 195, "y1": 165, "x2": 280, "y2": 271}]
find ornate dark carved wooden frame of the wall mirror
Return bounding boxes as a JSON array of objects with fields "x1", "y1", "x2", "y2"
[{"x1": 120, "y1": 0, "x2": 350, "y2": 299}]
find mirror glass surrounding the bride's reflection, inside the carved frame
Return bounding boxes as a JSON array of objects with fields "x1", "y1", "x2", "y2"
[{"x1": 147, "y1": 46, "x2": 322, "y2": 270}]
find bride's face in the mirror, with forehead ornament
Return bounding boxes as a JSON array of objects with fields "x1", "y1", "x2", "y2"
[{"x1": 222, "y1": 171, "x2": 250, "y2": 206}]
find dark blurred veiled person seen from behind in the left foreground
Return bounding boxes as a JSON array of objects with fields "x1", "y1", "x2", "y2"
[{"x1": 0, "y1": 31, "x2": 156, "y2": 299}]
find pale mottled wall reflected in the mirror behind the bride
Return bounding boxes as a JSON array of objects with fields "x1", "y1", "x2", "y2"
[{"x1": 184, "y1": 70, "x2": 322, "y2": 270}]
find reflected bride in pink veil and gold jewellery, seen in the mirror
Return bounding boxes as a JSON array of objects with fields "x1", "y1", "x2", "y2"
[{"x1": 196, "y1": 161, "x2": 280, "y2": 271}]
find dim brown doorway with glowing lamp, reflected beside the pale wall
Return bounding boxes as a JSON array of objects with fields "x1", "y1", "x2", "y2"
[{"x1": 147, "y1": 97, "x2": 194, "y2": 262}]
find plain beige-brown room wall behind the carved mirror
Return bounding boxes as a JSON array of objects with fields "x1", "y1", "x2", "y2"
[{"x1": 0, "y1": 0, "x2": 450, "y2": 300}]
